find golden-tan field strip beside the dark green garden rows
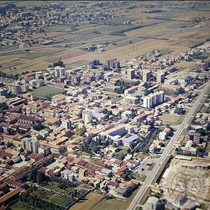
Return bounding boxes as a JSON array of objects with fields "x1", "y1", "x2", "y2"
[{"x1": 71, "y1": 192, "x2": 103, "y2": 210}]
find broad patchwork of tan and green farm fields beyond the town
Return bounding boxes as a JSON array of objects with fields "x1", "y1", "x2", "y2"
[{"x1": 0, "y1": 2, "x2": 210, "y2": 74}]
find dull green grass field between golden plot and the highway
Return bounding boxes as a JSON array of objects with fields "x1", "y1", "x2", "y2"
[{"x1": 91, "y1": 189, "x2": 138, "y2": 210}]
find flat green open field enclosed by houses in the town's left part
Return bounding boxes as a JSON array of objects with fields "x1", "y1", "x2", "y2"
[{"x1": 32, "y1": 86, "x2": 64, "y2": 97}]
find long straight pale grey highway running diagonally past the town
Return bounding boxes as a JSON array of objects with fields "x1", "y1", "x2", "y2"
[{"x1": 128, "y1": 81, "x2": 210, "y2": 210}]
